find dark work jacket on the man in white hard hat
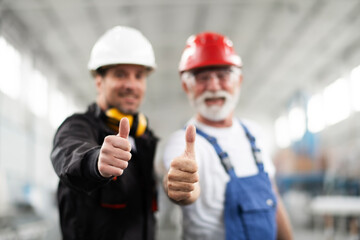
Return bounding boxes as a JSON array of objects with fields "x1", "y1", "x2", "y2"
[{"x1": 51, "y1": 104, "x2": 157, "y2": 240}]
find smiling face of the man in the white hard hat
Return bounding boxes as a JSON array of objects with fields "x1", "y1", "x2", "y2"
[{"x1": 95, "y1": 64, "x2": 148, "y2": 114}]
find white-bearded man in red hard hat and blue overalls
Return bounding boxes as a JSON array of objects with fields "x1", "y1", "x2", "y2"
[{"x1": 163, "y1": 32, "x2": 292, "y2": 240}]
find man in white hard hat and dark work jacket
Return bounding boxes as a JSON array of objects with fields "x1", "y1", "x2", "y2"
[{"x1": 51, "y1": 26, "x2": 158, "y2": 240}]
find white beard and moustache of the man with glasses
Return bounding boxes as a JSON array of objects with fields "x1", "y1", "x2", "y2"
[{"x1": 189, "y1": 88, "x2": 240, "y2": 121}]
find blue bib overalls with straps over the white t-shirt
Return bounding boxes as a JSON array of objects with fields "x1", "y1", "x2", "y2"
[{"x1": 196, "y1": 122, "x2": 277, "y2": 240}]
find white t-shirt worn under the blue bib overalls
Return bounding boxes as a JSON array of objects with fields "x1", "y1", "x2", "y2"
[{"x1": 163, "y1": 119, "x2": 275, "y2": 240}]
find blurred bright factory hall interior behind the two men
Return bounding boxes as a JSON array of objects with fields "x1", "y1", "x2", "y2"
[{"x1": 0, "y1": 0, "x2": 360, "y2": 240}]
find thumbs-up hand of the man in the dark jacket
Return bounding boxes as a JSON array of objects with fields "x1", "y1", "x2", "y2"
[{"x1": 97, "y1": 117, "x2": 131, "y2": 178}]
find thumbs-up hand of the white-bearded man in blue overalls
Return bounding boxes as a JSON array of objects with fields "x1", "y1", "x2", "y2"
[{"x1": 164, "y1": 125, "x2": 200, "y2": 205}]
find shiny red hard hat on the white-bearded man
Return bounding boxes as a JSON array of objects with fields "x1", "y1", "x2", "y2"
[{"x1": 179, "y1": 32, "x2": 242, "y2": 72}]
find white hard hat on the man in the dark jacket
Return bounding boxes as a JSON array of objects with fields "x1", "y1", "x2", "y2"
[{"x1": 88, "y1": 26, "x2": 156, "y2": 70}]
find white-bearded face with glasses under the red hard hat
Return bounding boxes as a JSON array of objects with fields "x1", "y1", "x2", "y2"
[{"x1": 182, "y1": 66, "x2": 242, "y2": 126}]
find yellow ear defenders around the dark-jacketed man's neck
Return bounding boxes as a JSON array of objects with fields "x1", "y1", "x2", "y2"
[{"x1": 105, "y1": 108, "x2": 147, "y2": 137}]
